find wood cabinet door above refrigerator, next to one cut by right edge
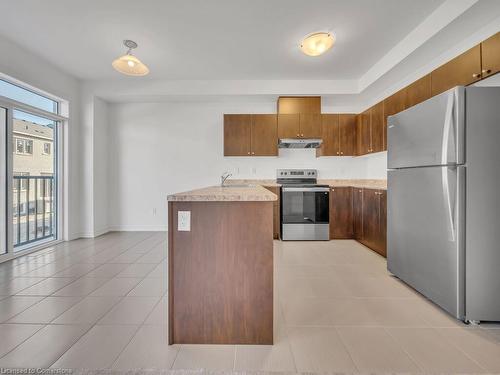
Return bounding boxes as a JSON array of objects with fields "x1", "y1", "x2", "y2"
[{"x1": 431, "y1": 45, "x2": 481, "y2": 96}]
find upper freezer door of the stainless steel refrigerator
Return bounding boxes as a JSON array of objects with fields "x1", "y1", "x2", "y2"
[{"x1": 387, "y1": 87, "x2": 465, "y2": 169}]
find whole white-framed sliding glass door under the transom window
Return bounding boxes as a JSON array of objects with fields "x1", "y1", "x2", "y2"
[{"x1": 0, "y1": 94, "x2": 64, "y2": 262}]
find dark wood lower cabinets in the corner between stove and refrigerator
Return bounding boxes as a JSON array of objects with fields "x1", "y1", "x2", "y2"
[{"x1": 330, "y1": 187, "x2": 387, "y2": 257}]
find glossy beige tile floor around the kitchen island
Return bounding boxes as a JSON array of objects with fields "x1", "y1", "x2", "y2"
[{"x1": 0, "y1": 232, "x2": 500, "y2": 373}]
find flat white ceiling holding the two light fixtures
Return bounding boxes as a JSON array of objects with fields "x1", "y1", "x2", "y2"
[{"x1": 0, "y1": 0, "x2": 444, "y2": 80}]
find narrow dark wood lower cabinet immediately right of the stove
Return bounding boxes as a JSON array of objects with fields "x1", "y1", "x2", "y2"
[{"x1": 330, "y1": 187, "x2": 354, "y2": 239}]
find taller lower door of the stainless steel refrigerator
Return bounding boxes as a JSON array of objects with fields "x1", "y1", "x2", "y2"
[{"x1": 387, "y1": 166, "x2": 465, "y2": 319}]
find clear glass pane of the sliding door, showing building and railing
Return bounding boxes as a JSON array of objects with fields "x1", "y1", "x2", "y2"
[{"x1": 11, "y1": 109, "x2": 59, "y2": 252}]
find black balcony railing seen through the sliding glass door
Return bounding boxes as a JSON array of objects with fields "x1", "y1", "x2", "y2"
[{"x1": 12, "y1": 176, "x2": 56, "y2": 248}]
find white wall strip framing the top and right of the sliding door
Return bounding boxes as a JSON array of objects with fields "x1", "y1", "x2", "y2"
[{"x1": 0, "y1": 37, "x2": 81, "y2": 239}]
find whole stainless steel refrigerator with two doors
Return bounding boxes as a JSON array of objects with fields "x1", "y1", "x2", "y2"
[{"x1": 387, "y1": 87, "x2": 500, "y2": 322}]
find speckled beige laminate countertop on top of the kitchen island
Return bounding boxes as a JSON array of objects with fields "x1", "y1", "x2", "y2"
[{"x1": 167, "y1": 185, "x2": 278, "y2": 202}]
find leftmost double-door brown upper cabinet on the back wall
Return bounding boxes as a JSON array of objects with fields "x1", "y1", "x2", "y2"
[{"x1": 224, "y1": 114, "x2": 278, "y2": 156}]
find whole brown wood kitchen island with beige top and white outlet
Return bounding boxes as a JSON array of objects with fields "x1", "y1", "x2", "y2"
[{"x1": 168, "y1": 185, "x2": 277, "y2": 345}]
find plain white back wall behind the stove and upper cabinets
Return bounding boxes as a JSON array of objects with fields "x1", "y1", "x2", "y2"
[{"x1": 108, "y1": 102, "x2": 386, "y2": 230}]
